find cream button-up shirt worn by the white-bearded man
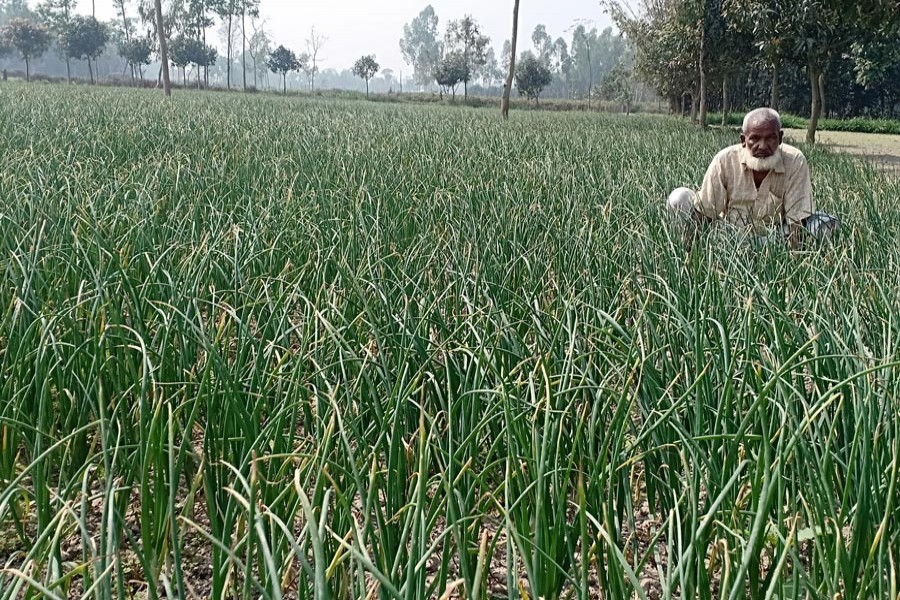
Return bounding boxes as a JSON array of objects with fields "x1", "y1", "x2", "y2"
[{"x1": 695, "y1": 144, "x2": 815, "y2": 229}]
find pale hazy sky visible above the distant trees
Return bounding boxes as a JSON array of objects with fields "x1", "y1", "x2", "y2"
[{"x1": 79, "y1": 0, "x2": 610, "y2": 76}]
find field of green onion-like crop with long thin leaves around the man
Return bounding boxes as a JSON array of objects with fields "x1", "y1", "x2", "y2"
[{"x1": 0, "y1": 85, "x2": 900, "y2": 599}]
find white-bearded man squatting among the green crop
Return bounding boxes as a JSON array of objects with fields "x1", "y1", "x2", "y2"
[{"x1": 668, "y1": 108, "x2": 839, "y2": 248}]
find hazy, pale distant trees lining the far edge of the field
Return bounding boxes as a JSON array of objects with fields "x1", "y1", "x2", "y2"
[{"x1": 0, "y1": 0, "x2": 648, "y2": 102}]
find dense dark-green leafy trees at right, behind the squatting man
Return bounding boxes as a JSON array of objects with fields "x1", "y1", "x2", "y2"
[{"x1": 606, "y1": 0, "x2": 900, "y2": 143}]
